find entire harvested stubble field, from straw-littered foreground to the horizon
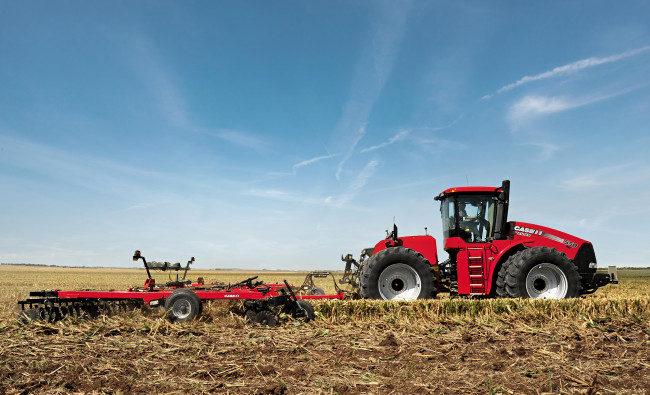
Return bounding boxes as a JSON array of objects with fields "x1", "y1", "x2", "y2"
[{"x1": 0, "y1": 266, "x2": 650, "y2": 394}]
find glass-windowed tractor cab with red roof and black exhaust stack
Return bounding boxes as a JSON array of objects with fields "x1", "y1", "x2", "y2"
[{"x1": 435, "y1": 180, "x2": 510, "y2": 249}]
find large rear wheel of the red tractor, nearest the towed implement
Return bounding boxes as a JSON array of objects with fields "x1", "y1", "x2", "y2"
[{"x1": 359, "y1": 247, "x2": 436, "y2": 300}]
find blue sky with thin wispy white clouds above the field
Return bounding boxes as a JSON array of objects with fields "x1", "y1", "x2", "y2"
[{"x1": 0, "y1": 1, "x2": 650, "y2": 269}]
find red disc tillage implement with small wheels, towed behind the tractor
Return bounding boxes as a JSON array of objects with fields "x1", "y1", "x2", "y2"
[{"x1": 18, "y1": 251, "x2": 345, "y2": 326}]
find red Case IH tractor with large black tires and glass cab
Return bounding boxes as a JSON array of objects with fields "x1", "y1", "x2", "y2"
[{"x1": 341, "y1": 180, "x2": 618, "y2": 300}]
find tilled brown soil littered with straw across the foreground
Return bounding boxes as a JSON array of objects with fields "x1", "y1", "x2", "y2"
[{"x1": 0, "y1": 311, "x2": 650, "y2": 394}]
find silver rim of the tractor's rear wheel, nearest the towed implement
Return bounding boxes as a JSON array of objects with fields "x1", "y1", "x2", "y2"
[{"x1": 379, "y1": 263, "x2": 422, "y2": 300}]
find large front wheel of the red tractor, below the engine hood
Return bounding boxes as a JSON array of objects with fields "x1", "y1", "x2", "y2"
[{"x1": 504, "y1": 247, "x2": 582, "y2": 299}]
